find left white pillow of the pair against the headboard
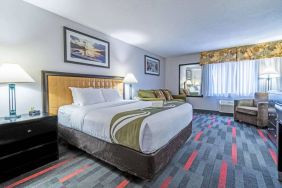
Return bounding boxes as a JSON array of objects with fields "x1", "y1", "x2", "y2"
[{"x1": 70, "y1": 88, "x2": 105, "y2": 106}]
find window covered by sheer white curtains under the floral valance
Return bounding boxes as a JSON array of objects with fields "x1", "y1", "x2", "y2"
[{"x1": 203, "y1": 58, "x2": 282, "y2": 97}]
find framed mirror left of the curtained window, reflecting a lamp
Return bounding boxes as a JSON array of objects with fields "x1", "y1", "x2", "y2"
[{"x1": 179, "y1": 63, "x2": 202, "y2": 97}]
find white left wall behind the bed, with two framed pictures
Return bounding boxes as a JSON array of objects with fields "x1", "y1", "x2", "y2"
[{"x1": 0, "y1": 0, "x2": 165, "y2": 116}]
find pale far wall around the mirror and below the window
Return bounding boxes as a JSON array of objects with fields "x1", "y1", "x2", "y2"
[{"x1": 165, "y1": 54, "x2": 219, "y2": 111}]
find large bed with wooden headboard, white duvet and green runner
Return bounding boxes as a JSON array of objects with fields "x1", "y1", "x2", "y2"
[{"x1": 43, "y1": 72, "x2": 192, "y2": 179}]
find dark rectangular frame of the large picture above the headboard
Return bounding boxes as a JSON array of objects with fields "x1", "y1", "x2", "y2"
[{"x1": 63, "y1": 26, "x2": 111, "y2": 69}]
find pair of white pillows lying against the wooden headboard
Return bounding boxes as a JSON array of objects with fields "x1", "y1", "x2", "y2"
[{"x1": 70, "y1": 87, "x2": 122, "y2": 106}]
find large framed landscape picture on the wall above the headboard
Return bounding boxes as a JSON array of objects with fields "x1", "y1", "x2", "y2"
[{"x1": 64, "y1": 27, "x2": 110, "y2": 68}]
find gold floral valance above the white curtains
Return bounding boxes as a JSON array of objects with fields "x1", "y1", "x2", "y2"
[{"x1": 200, "y1": 41, "x2": 282, "y2": 64}]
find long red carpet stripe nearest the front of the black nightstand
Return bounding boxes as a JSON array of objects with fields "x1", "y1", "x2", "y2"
[{"x1": 5, "y1": 158, "x2": 73, "y2": 188}]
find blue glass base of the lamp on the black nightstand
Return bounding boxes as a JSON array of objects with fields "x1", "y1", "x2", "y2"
[{"x1": 4, "y1": 84, "x2": 21, "y2": 120}]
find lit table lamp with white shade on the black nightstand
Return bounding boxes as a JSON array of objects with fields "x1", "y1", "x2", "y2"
[{"x1": 0, "y1": 64, "x2": 34, "y2": 120}]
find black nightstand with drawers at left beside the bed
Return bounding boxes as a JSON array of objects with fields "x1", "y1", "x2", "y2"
[{"x1": 0, "y1": 114, "x2": 59, "y2": 182}]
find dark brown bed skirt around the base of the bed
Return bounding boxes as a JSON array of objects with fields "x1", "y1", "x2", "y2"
[{"x1": 58, "y1": 121, "x2": 192, "y2": 179}]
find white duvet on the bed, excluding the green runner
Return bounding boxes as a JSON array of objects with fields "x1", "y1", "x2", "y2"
[{"x1": 58, "y1": 100, "x2": 192, "y2": 154}]
